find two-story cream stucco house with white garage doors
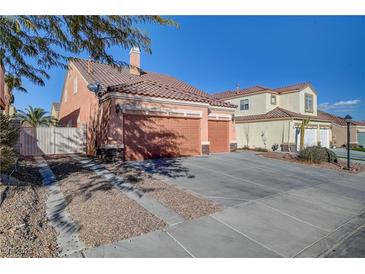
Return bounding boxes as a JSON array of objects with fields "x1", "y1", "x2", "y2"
[{"x1": 215, "y1": 83, "x2": 332, "y2": 151}]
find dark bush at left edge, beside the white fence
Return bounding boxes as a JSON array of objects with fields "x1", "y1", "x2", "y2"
[{"x1": 0, "y1": 113, "x2": 19, "y2": 172}]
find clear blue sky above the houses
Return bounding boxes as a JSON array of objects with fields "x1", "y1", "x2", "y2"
[{"x1": 14, "y1": 16, "x2": 365, "y2": 120}]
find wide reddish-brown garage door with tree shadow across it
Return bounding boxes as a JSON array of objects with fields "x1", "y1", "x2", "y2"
[{"x1": 124, "y1": 114, "x2": 201, "y2": 160}]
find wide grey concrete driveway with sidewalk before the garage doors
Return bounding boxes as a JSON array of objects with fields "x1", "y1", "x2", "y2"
[{"x1": 76, "y1": 152, "x2": 365, "y2": 257}]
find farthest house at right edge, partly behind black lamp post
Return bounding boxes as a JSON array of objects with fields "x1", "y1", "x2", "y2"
[{"x1": 318, "y1": 110, "x2": 365, "y2": 147}]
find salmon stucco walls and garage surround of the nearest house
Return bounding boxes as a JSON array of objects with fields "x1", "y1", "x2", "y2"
[{"x1": 59, "y1": 64, "x2": 236, "y2": 154}]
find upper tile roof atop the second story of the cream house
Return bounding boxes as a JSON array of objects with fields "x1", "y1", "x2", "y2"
[{"x1": 214, "y1": 83, "x2": 310, "y2": 100}]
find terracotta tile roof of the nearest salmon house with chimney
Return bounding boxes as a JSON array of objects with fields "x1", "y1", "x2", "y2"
[{"x1": 72, "y1": 59, "x2": 237, "y2": 108}]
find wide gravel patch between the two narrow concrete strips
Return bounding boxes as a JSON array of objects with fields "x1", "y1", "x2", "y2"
[{"x1": 47, "y1": 157, "x2": 166, "y2": 247}]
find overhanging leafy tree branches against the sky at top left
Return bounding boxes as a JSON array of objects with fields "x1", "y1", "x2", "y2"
[{"x1": 0, "y1": 16, "x2": 176, "y2": 91}]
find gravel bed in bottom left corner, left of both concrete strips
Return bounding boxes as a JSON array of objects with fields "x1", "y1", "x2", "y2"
[{"x1": 0, "y1": 182, "x2": 58, "y2": 257}]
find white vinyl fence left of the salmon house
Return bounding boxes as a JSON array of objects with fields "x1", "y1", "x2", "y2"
[{"x1": 19, "y1": 127, "x2": 86, "y2": 156}]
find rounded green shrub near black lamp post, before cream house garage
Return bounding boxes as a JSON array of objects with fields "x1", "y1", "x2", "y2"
[{"x1": 299, "y1": 146, "x2": 337, "y2": 164}]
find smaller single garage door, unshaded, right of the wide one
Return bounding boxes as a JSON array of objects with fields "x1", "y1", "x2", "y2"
[{"x1": 208, "y1": 120, "x2": 229, "y2": 153}]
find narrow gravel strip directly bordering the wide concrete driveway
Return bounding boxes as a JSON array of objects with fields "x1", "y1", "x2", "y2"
[{"x1": 104, "y1": 162, "x2": 222, "y2": 220}]
